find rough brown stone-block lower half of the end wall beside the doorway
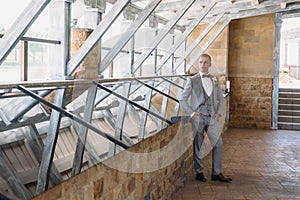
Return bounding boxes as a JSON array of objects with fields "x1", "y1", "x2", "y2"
[{"x1": 229, "y1": 77, "x2": 272, "y2": 129}]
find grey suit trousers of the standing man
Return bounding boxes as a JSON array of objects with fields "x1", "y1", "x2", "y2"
[{"x1": 192, "y1": 115, "x2": 223, "y2": 175}]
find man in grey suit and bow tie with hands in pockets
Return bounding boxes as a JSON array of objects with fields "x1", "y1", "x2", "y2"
[{"x1": 179, "y1": 54, "x2": 232, "y2": 182}]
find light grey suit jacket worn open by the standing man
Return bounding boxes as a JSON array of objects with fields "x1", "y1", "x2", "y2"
[{"x1": 179, "y1": 73, "x2": 224, "y2": 119}]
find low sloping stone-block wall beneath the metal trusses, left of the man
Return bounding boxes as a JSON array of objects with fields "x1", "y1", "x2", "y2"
[{"x1": 34, "y1": 123, "x2": 193, "y2": 200}]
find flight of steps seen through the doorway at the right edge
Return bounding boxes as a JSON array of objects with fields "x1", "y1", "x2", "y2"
[{"x1": 278, "y1": 88, "x2": 300, "y2": 130}]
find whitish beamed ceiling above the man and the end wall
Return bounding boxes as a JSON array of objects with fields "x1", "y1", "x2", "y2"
[{"x1": 125, "y1": 0, "x2": 300, "y2": 26}]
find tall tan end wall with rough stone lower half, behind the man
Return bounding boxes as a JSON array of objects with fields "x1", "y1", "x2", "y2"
[{"x1": 228, "y1": 14, "x2": 275, "y2": 129}]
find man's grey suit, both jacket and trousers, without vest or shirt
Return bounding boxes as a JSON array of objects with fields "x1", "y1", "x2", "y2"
[{"x1": 179, "y1": 73, "x2": 224, "y2": 175}]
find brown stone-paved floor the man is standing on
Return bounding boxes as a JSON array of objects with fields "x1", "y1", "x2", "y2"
[{"x1": 172, "y1": 129, "x2": 300, "y2": 200}]
